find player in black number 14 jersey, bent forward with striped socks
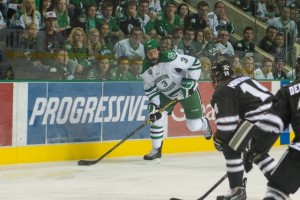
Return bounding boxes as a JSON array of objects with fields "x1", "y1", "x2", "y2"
[{"x1": 211, "y1": 60, "x2": 275, "y2": 200}]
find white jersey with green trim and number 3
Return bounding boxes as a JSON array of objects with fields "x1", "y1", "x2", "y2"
[{"x1": 140, "y1": 51, "x2": 201, "y2": 105}]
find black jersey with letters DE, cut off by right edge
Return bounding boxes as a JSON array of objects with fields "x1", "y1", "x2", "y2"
[{"x1": 257, "y1": 78, "x2": 300, "y2": 143}]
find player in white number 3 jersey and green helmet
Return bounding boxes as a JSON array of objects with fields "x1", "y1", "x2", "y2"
[{"x1": 141, "y1": 39, "x2": 212, "y2": 160}]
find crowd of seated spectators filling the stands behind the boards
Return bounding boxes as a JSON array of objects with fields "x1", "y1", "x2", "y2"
[{"x1": 0, "y1": 0, "x2": 300, "y2": 81}]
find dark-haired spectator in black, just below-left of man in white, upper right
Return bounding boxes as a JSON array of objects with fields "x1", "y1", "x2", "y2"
[{"x1": 258, "y1": 26, "x2": 277, "y2": 54}]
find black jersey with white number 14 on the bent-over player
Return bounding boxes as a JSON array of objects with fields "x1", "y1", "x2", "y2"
[{"x1": 211, "y1": 76, "x2": 273, "y2": 140}]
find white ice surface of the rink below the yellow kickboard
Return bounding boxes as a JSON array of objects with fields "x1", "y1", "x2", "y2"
[{"x1": 0, "y1": 146, "x2": 300, "y2": 200}]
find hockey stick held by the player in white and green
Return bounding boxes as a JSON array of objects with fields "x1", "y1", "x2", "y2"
[{"x1": 78, "y1": 99, "x2": 177, "y2": 166}]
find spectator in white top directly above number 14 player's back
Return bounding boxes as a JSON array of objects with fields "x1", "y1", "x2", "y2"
[{"x1": 254, "y1": 57, "x2": 274, "y2": 80}]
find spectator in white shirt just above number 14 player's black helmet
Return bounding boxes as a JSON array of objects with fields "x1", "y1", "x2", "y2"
[{"x1": 216, "y1": 30, "x2": 234, "y2": 56}]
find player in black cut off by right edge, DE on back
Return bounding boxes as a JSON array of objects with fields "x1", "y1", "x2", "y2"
[{"x1": 244, "y1": 57, "x2": 300, "y2": 200}]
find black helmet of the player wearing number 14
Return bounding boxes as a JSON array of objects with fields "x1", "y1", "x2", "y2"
[{"x1": 210, "y1": 60, "x2": 233, "y2": 87}]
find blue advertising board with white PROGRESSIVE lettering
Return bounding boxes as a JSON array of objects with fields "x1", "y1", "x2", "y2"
[{"x1": 27, "y1": 82, "x2": 149, "y2": 144}]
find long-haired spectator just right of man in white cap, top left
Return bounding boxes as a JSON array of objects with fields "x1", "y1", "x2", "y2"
[{"x1": 53, "y1": 0, "x2": 71, "y2": 36}]
